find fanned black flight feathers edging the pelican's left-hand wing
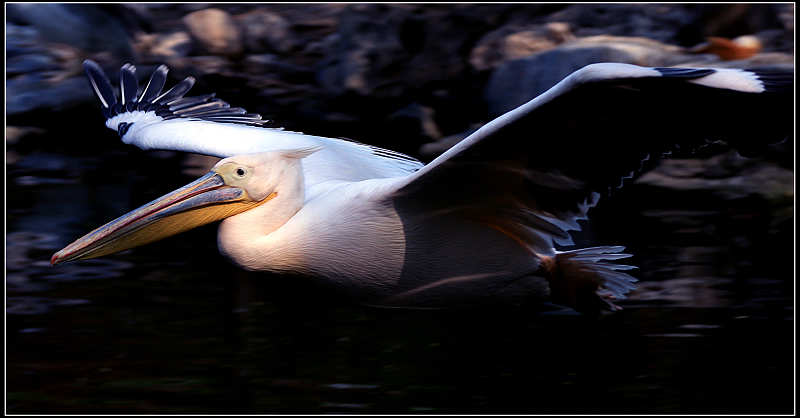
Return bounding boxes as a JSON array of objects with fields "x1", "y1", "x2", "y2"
[{"x1": 83, "y1": 59, "x2": 267, "y2": 125}]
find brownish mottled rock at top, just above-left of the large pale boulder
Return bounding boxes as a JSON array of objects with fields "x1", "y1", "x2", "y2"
[{"x1": 469, "y1": 22, "x2": 575, "y2": 71}]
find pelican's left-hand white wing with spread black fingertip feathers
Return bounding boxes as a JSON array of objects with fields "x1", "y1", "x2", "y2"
[{"x1": 83, "y1": 60, "x2": 422, "y2": 186}]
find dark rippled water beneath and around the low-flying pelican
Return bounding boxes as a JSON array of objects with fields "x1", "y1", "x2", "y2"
[{"x1": 6, "y1": 148, "x2": 794, "y2": 414}]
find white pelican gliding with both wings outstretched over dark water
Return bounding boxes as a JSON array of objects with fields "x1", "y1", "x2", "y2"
[{"x1": 51, "y1": 60, "x2": 794, "y2": 312}]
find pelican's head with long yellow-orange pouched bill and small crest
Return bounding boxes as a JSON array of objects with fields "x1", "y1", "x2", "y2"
[{"x1": 50, "y1": 148, "x2": 316, "y2": 264}]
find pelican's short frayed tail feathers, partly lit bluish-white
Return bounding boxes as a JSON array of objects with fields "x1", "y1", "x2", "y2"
[{"x1": 541, "y1": 246, "x2": 638, "y2": 312}]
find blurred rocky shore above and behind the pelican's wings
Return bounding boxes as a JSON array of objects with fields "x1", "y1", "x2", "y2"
[{"x1": 6, "y1": 4, "x2": 794, "y2": 193}]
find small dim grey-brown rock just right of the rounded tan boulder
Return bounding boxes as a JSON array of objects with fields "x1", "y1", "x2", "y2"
[{"x1": 234, "y1": 9, "x2": 297, "y2": 53}]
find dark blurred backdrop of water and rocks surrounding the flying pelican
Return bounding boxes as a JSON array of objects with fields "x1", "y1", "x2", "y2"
[{"x1": 6, "y1": 4, "x2": 794, "y2": 414}]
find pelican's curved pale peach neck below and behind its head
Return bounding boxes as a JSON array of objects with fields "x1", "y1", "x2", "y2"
[{"x1": 217, "y1": 161, "x2": 305, "y2": 268}]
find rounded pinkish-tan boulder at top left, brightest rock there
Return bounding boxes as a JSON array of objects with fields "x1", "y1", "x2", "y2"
[{"x1": 183, "y1": 9, "x2": 244, "y2": 56}]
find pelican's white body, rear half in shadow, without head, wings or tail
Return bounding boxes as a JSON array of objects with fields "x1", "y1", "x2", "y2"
[{"x1": 217, "y1": 160, "x2": 547, "y2": 307}]
